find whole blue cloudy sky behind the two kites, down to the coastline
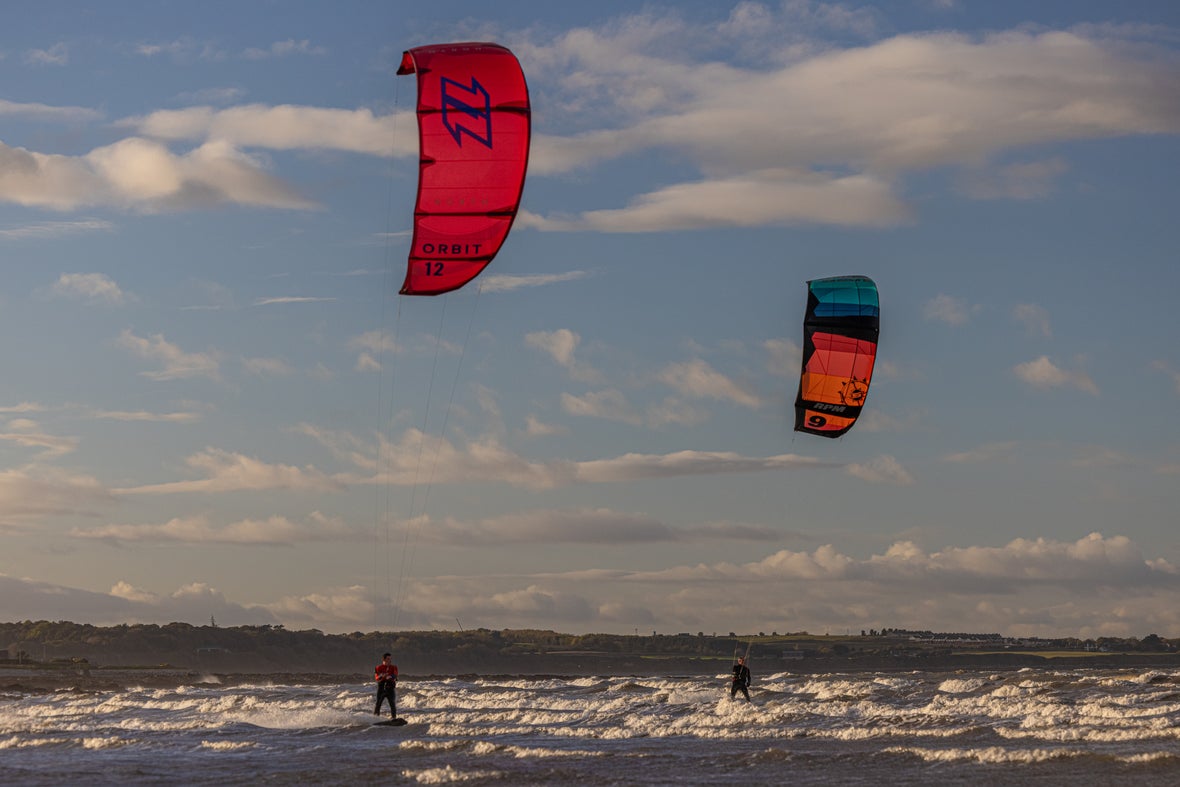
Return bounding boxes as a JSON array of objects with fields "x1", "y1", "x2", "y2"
[{"x1": 0, "y1": 0, "x2": 1180, "y2": 645}]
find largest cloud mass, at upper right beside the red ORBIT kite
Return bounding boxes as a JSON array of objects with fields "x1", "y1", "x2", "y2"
[{"x1": 523, "y1": 18, "x2": 1180, "y2": 232}]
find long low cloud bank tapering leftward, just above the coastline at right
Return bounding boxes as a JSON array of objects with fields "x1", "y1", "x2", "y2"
[{"x1": 263, "y1": 533, "x2": 1180, "y2": 636}]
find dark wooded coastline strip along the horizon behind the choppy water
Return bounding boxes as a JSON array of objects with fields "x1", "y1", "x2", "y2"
[{"x1": 0, "y1": 621, "x2": 1180, "y2": 690}]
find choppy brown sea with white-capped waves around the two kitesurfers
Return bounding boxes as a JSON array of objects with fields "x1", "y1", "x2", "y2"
[{"x1": 0, "y1": 663, "x2": 1180, "y2": 787}]
